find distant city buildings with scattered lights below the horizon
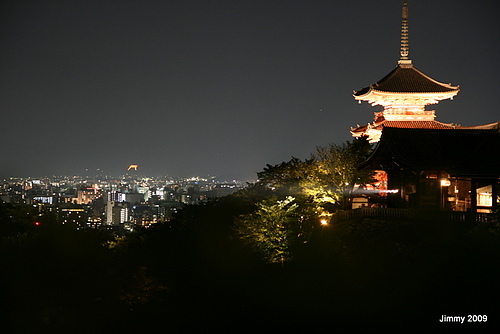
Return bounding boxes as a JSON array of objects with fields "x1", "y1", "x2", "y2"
[{"x1": 0, "y1": 175, "x2": 244, "y2": 231}]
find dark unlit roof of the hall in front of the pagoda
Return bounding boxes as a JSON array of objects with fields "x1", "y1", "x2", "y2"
[{"x1": 359, "y1": 128, "x2": 500, "y2": 177}]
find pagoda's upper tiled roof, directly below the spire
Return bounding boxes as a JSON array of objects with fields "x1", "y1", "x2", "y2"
[{"x1": 354, "y1": 63, "x2": 459, "y2": 96}]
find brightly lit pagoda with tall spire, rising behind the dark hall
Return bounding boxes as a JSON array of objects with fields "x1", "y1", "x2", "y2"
[{"x1": 351, "y1": 1, "x2": 460, "y2": 142}]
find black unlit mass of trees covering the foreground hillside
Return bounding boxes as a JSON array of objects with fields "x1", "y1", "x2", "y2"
[{"x1": 0, "y1": 190, "x2": 500, "y2": 333}]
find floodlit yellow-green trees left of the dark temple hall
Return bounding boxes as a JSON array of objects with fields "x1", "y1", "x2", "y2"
[{"x1": 235, "y1": 138, "x2": 371, "y2": 263}]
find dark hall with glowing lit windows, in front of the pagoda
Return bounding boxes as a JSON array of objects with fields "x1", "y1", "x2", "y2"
[{"x1": 361, "y1": 128, "x2": 500, "y2": 213}]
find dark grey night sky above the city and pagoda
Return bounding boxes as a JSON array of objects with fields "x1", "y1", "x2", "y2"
[{"x1": 0, "y1": 0, "x2": 500, "y2": 180}]
